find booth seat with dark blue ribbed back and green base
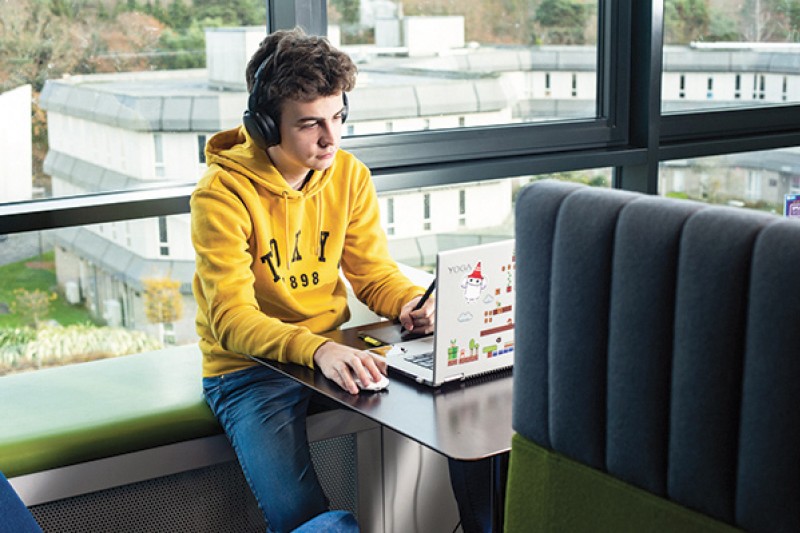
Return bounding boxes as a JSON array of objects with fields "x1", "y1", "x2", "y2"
[{"x1": 506, "y1": 181, "x2": 800, "y2": 532}]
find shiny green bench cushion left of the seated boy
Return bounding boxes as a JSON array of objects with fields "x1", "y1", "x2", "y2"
[{"x1": 0, "y1": 345, "x2": 221, "y2": 477}]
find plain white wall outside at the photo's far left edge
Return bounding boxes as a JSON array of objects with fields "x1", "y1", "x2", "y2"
[{"x1": 0, "y1": 85, "x2": 33, "y2": 202}]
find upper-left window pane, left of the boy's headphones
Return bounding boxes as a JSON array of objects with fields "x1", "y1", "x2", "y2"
[{"x1": 0, "y1": 0, "x2": 266, "y2": 203}]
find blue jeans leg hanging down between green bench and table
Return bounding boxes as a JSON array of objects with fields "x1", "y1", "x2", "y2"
[{"x1": 203, "y1": 366, "x2": 328, "y2": 532}]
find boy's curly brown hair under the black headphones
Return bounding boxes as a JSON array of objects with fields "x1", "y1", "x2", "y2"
[{"x1": 245, "y1": 27, "x2": 357, "y2": 120}]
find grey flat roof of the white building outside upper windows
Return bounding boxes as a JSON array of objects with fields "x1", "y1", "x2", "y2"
[{"x1": 40, "y1": 46, "x2": 800, "y2": 132}]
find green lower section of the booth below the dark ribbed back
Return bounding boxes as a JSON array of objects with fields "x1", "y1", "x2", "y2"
[{"x1": 505, "y1": 434, "x2": 740, "y2": 533}]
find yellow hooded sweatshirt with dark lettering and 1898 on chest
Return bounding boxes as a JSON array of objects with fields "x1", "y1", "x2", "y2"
[{"x1": 191, "y1": 127, "x2": 423, "y2": 377}]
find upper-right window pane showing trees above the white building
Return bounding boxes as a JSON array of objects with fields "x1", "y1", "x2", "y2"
[{"x1": 662, "y1": 0, "x2": 800, "y2": 112}]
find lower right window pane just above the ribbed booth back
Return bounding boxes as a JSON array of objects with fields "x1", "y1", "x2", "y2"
[{"x1": 659, "y1": 148, "x2": 800, "y2": 215}]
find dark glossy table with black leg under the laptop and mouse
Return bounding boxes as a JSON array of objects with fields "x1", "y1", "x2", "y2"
[{"x1": 263, "y1": 323, "x2": 512, "y2": 531}]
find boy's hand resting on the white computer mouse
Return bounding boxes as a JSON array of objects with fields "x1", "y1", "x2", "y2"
[{"x1": 314, "y1": 341, "x2": 386, "y2": 394}]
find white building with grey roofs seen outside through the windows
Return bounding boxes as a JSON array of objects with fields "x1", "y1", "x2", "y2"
[{"x1": 41, "y1": 24, "x2": 800, "y2": 342}]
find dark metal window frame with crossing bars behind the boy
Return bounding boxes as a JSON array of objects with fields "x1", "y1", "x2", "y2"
[{"x1": 0, "y1": 0, "x2": 800, "y2": 234}]
